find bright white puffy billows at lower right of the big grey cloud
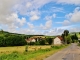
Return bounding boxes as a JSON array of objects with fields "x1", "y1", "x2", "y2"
[{"x1": 5, "y1": 13, "x2": 26, "y2": 26}]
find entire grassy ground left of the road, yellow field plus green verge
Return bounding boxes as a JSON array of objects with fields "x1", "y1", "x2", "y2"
[{"x1": 0, "y1": 46, "x2": 69, "y2": 60}]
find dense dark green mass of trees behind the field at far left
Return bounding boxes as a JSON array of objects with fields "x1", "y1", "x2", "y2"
[{"x1": 0, "y1": 33, "x2": 26, "y2": 47}]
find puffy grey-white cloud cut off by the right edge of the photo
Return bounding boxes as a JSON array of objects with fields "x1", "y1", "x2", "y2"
[{"x1": 66, "y1": 7, "x2": 80, "y2": 23}]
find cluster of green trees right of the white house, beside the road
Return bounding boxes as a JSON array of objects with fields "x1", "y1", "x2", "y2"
[{"x1": 61, "y1": 30, "x2": 78, "y2": 44}]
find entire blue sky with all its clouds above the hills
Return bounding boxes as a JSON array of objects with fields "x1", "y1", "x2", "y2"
[{"x1": 0, "y1": 0, "x2": 80, "y2": 36}]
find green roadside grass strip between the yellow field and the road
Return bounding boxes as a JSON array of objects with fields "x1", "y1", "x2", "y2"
[{"x1": 0, "y1": 45, "x2": 67, "y2": 60}]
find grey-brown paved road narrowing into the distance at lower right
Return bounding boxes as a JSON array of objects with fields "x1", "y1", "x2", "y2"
[{"x1": 44, "y1": 43, "x2": 80, "y2": 60}]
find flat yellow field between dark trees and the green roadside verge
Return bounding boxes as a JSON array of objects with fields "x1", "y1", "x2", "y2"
[{"x1": 0, "y1": 45, "x2": 50, "y2": 54}]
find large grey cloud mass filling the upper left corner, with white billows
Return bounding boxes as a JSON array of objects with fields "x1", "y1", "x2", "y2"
[{"x1": 0, "y1": 0, "x2": 26, "y2": 29}]
